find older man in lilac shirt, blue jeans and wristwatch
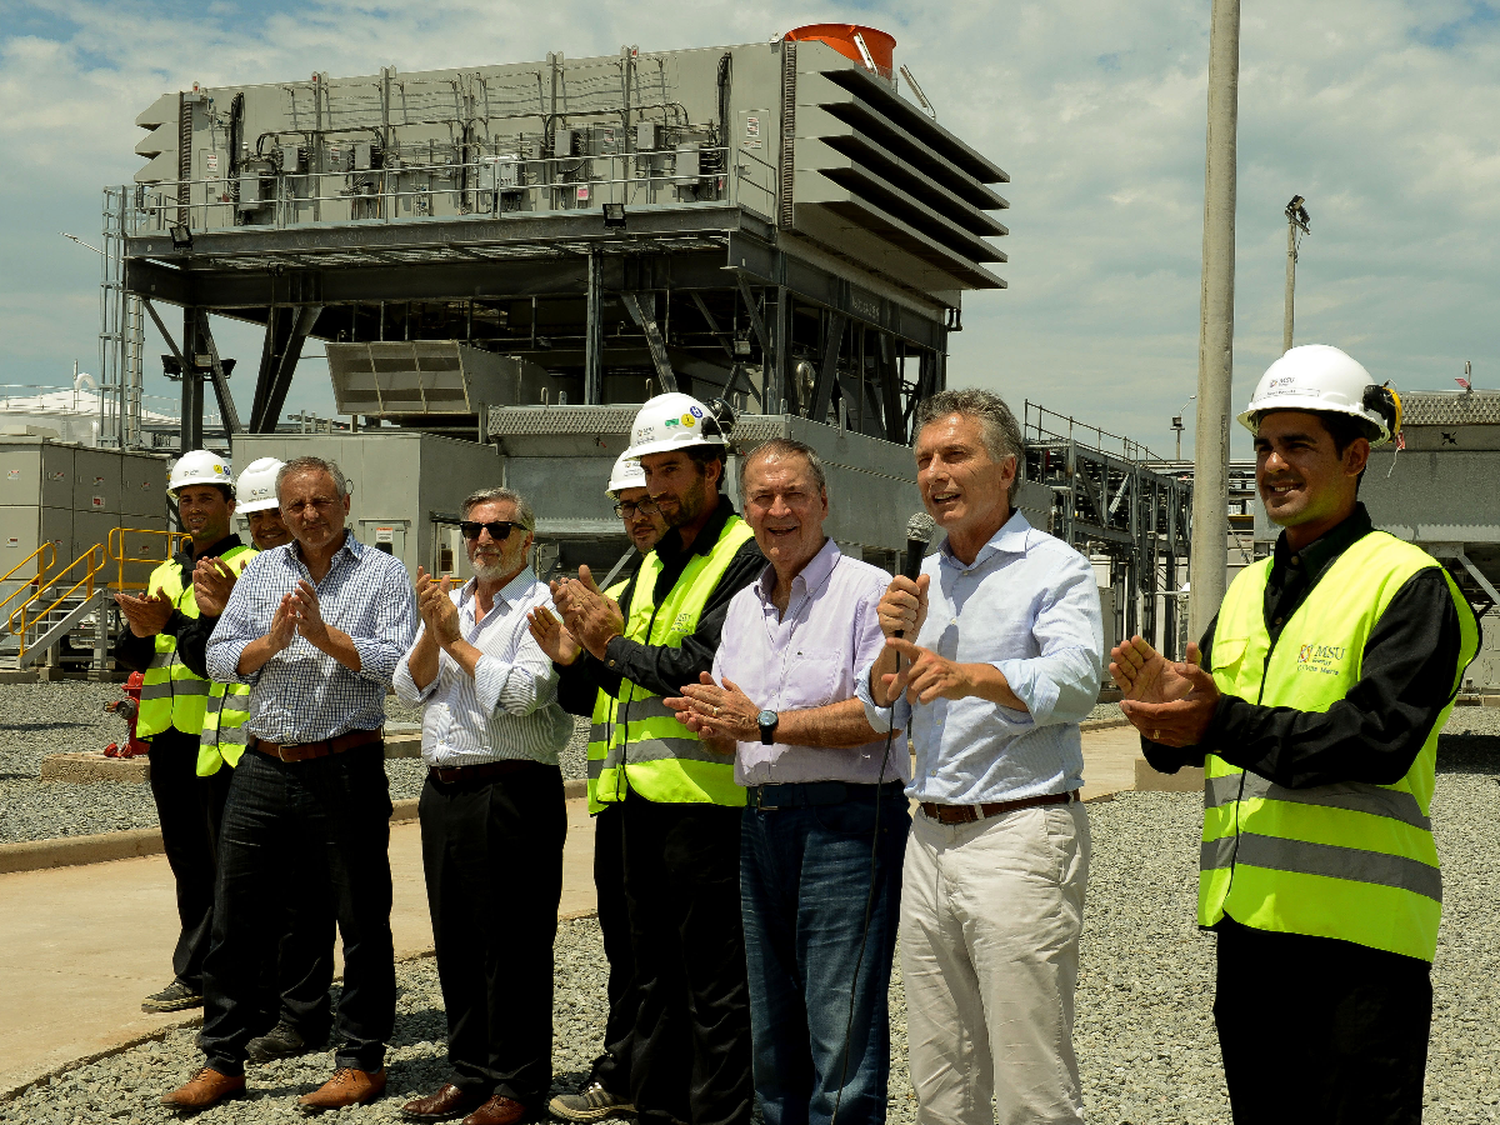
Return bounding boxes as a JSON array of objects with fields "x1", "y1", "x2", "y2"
[{"x1": 666, "y1": 438, "x2": 911, "y2": 1125}]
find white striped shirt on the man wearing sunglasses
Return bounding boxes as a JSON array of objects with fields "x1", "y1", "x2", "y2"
[{"x1": 395, "y1": 567, "x2": 573, "y2": 770}]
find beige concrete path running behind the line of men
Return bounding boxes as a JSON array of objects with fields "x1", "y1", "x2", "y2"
[{"x1": 0, "y1": 725, "x2": 1140, "y2": 1100}]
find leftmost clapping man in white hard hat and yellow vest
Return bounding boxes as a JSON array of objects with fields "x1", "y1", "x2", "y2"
[{"x1": 114, "y1": 450, "x2": 255, "y2": 1011}]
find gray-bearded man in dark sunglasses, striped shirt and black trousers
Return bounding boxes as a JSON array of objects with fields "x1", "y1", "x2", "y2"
[{"x1": 395, "y1": 489, "x2": 573, "y2": 1125}]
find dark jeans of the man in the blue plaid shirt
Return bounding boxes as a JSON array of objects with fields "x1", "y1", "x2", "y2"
[{"x1": 200, "y1": 743, "x2": 396, "y2": 1074}]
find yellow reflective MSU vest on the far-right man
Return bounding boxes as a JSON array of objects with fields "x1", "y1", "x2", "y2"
[{"x1": 1199, "y1": 531, "x2": 1478, "y2": 962}]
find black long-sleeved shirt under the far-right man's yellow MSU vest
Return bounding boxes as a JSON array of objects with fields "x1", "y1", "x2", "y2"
[{"x1": 1140, "y1": 504, "x2": 1460, "y2": 789}]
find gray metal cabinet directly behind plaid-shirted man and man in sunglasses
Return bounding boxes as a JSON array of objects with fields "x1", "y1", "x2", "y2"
[{"x1": 233, "y1": 429, "x2": 504, "y2": 581}]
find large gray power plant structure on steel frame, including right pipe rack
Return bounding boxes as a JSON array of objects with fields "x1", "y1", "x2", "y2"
[{"x1": 5, "y1": 26, "x2": 1188, "y2": 675}]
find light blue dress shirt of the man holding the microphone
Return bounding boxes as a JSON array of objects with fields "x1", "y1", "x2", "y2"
[{"x1": 857, "y1": 512, "x2": 1104, "y2": 804}]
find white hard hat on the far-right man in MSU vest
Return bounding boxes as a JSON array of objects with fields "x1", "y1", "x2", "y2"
[{"x1": 1239, "y1": 344, "x2": 1401, "y2": 446}]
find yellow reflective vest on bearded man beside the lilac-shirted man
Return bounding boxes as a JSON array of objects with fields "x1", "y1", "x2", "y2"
[{"x1": 594, "y1": 516, "x2": 753, "y2": 807}]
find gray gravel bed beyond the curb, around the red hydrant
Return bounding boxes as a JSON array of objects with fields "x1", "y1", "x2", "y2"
[{"x1": 0, "y1": 681, "x2": 588, "y2": 843}]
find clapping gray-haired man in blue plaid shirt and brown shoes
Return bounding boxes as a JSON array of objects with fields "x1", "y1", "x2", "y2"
[{"x1": 162, "y1": 458, "x2": 417, "y2": 1112}]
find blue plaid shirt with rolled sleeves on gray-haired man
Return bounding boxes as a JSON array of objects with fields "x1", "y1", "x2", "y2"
[{"x1": 209, "y1": 533, "x2": 417, "y2": 743}]
